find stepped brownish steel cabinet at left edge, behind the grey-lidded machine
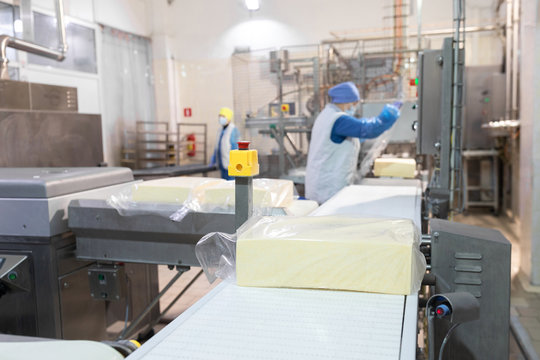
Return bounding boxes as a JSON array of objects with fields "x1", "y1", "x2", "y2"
[{"x1": 0, "y1": 80, "x2": 103, "y2": 167}]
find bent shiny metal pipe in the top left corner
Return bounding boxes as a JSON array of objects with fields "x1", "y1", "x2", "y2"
[{"x1": 0, "y1": 0, "x2": 68, "y2": 80}]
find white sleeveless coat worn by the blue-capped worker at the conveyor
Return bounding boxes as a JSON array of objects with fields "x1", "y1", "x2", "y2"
[{"x1": 305, "y1": 104, "x2": 360, "y2": 204}]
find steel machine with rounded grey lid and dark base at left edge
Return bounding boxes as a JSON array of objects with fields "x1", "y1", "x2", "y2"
[{"x1": 0, "y1": 168, "x2": 158, "y2": 340}]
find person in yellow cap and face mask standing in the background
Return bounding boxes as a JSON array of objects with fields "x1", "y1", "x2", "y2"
[{"x1": 210, "y1": 108, "x2": 240, "y2": 180}]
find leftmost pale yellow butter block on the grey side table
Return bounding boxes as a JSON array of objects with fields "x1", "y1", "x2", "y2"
[{"x1": 132, "y1": 176, "x2": 226, "y2": 203}]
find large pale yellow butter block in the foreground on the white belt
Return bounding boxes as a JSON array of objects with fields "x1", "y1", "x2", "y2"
[{"x1": 236, "y1": 216, "x2": 426, "y2": 295}]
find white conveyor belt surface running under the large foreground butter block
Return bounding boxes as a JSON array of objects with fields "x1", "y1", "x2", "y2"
[{"x1": 128, "y1": 179, "x2": 421, "y2": 360}]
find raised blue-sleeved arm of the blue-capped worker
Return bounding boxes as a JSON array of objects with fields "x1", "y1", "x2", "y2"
[{"x1": 330, "y1": 105, "x2": 399, "y2": 144}]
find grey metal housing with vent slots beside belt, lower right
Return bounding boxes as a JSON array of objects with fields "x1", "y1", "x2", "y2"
[{"x1": 429, "y1": 219, "x2": 512, "y2": 360}]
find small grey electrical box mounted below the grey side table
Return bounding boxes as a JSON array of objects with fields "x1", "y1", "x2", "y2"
[{"x1": 88, "y1": 265, "x2": 127, "y2": 301}]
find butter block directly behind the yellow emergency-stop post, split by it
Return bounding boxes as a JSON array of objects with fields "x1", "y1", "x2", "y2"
[{"x1": 204, "y1": 179, "x2": 294, "y2": 207}]
